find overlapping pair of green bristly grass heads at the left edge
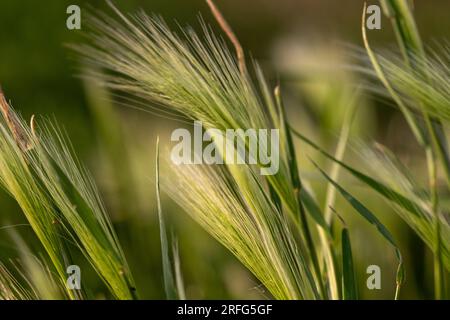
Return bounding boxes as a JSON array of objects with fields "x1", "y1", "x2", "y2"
[{"x1": 0, "y1": 89, "x2": 135, "y2": 299}]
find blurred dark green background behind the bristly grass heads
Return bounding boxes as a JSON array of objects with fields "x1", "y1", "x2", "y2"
[{"x1": 0, "y1": 0, "x2": 450, "y2": 299}]
